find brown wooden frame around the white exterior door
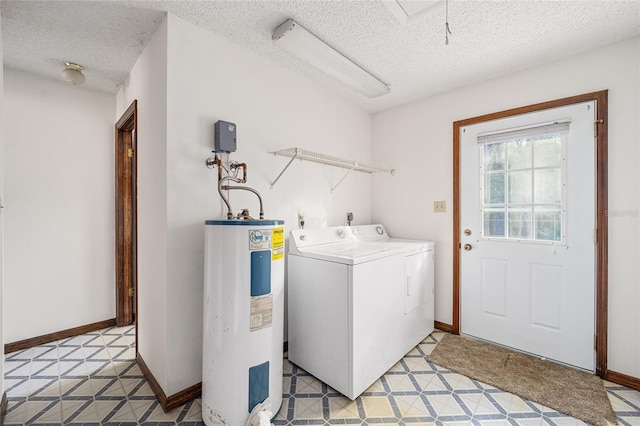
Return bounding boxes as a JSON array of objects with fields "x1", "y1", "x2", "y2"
[{"x1": 451, "y1": 90, "x2": 609, "y2": 379}]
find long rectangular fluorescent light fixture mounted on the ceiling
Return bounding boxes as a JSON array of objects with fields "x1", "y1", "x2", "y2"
[{"x1": 272, "y1": 19, "x2": 391, "y2": 98}]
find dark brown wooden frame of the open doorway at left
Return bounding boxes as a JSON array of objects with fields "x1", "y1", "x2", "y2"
[{"x1": 115, "y1": 100, "x2": 138, "y2": 328}]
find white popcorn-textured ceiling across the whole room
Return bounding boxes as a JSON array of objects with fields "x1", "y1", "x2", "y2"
[{"x1": 2, "y1": 0, "x2": 640, "y2": 111}]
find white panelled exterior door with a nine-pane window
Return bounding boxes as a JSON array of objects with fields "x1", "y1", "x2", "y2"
[{"x1": 460, "y1": 102, "x2": 596, "y2": 371}]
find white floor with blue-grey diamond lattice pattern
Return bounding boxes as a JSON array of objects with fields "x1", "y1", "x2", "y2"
[{"x1": 5, "y1": 327, "x2": 640, "y2": 426}]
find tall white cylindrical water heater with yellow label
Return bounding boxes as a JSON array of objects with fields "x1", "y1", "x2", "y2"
[{"x1": 202, "y1": 219, "x2": 284, "y2": 426}]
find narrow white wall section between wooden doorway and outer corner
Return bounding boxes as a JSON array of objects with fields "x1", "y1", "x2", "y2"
[{"x1": 117, "y1": 20, "x2": 169, "y2": 395}]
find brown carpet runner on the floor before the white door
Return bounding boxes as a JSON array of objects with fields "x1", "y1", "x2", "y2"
[{"x1": 429, "y1": 334, "x2": 617, "y2": 426}]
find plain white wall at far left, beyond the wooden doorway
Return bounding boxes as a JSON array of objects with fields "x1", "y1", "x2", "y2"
[{"x1": 2, "y1": 69, "x2": 115, "y2": 342}]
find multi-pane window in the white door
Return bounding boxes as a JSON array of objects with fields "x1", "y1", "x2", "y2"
[{"x1": 478, "y1": 121, "x2": 569, "y2": 244}]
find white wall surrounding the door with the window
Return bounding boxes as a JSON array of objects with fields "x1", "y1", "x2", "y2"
[{"x1": 372, "y1": 38, "x2": 640, "y2": 377}]
